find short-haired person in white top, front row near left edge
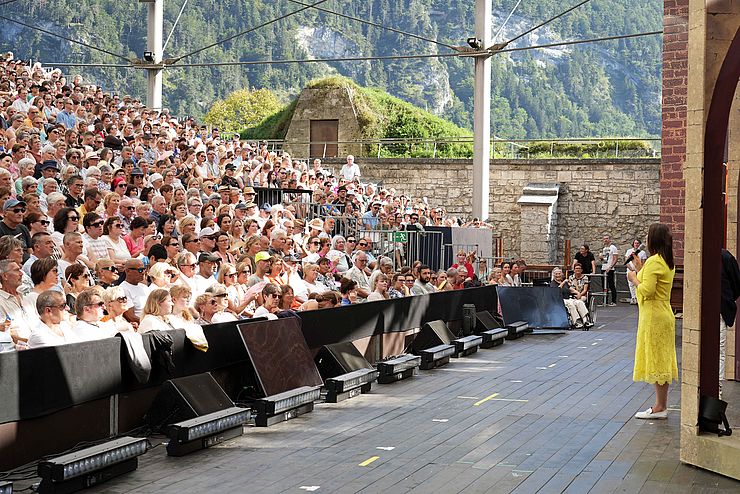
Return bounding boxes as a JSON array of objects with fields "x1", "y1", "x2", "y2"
[{"x1": 28, "y1": 290, "x2": 79, "y2": 348}]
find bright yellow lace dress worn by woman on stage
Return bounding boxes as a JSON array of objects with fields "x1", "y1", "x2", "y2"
[{"x1": 632, "y1": 254, "x2": 678, "y2": 384}]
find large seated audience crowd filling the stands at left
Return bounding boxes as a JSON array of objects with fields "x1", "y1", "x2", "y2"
[{"x1": 0, "y1": 53, "x2": 522, "y2": 350}]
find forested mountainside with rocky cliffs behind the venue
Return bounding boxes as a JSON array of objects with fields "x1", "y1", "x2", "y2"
[{"x1": 0, "y1": 0, "x2": 663, "y2": 138}]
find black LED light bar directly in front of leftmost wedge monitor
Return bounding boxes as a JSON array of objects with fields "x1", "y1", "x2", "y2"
[{"x1": 167, "y1": 407, "x2": 252, "y2": 456}]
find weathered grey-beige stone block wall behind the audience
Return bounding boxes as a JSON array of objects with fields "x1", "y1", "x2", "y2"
[{"x1": 326, "y1": 158, "x2": 661, "y2": 261}]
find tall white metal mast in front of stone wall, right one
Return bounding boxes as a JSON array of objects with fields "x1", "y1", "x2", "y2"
[{"x1": 473, "y1": 0, "x2": 493, "y2": 221}]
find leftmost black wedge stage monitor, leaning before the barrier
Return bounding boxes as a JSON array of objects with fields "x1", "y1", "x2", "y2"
[{"x1": 145, "y1": 372, "x2": 234, "y2": 431}]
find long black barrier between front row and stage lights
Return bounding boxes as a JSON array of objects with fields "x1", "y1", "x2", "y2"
[{"x1": 0, "y1": 286, "x2": 497, "y2": 470}]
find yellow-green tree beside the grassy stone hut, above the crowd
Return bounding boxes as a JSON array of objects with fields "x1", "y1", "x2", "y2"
[{"x1": 204, "y1": 89, "x2": 282, "y2": 132}]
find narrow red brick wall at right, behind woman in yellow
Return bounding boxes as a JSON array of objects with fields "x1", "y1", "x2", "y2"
[{"x1": 660, "y1": 0, "x2": 689, "y2": 263}]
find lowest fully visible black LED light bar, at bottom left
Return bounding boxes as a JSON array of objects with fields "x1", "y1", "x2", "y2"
[{"x1": 38, "y1": 436, "x2": 149, "y2": 494}]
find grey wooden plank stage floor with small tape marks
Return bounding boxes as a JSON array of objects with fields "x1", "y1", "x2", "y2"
[{"x1": 50, "y1": 305, "x2": 740, "y2": 494}]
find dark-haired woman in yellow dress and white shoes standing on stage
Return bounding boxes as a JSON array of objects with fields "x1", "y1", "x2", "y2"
[{"x1": 628, "y1": 223, "x2": 678, "y2": 420}]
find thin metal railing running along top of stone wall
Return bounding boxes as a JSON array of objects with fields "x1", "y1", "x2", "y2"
[{"x1": 258, "y1": 136, "x2": 661, "y2": 159}]
